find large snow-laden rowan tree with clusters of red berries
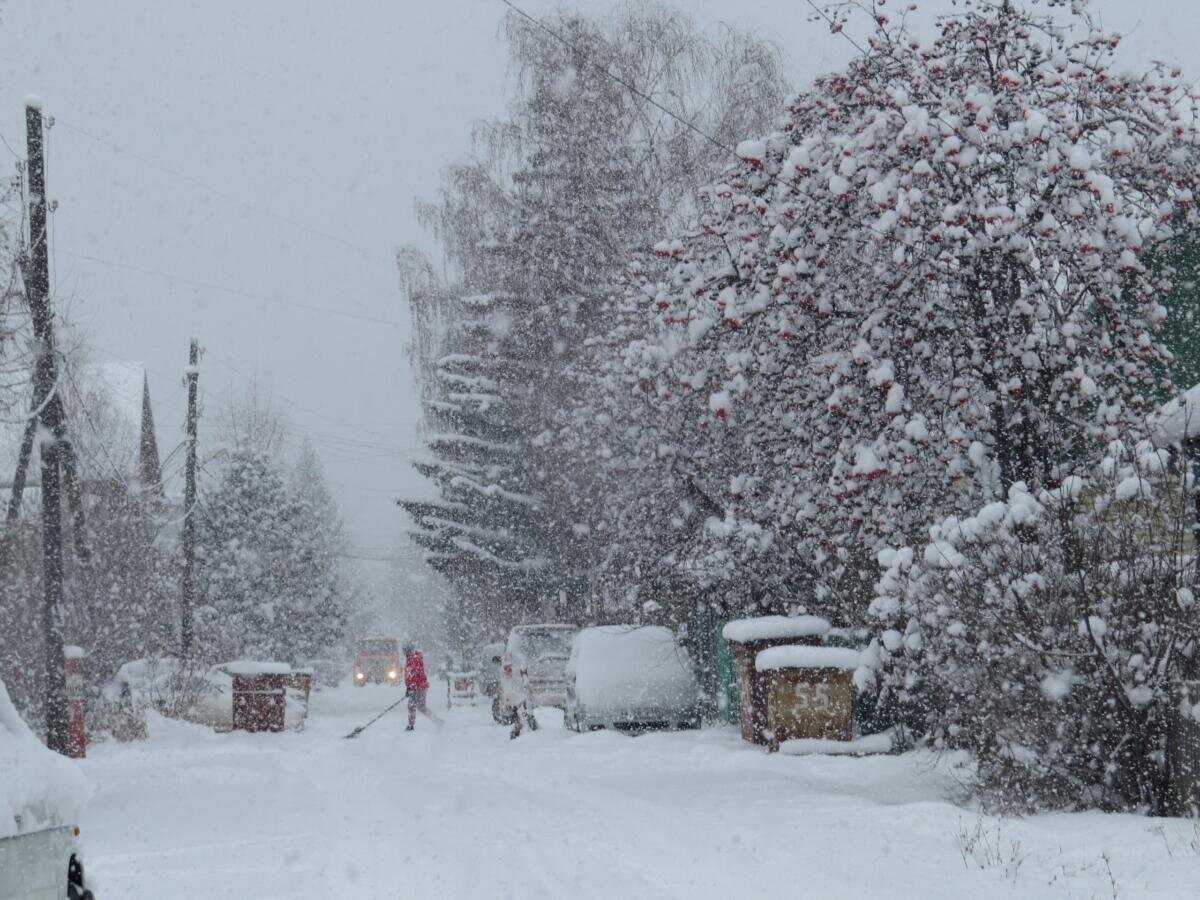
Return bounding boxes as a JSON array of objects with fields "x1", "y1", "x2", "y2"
[{"x1": 630, "y1": 0, "x2": 1196, "y2": 617}]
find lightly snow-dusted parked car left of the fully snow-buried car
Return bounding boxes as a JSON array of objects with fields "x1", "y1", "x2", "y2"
[{"x1": 492, "y1": 625, "x2": 578, "y2": 725}]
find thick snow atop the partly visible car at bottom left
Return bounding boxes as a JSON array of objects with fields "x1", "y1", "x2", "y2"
[{"x1": 0, "y1": 682, "x2": 88, "y2": 838}]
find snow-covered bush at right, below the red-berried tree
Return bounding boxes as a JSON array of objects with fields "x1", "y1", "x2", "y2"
[{"x1": 871, "y1": 442, "x2": 1200, "y2": 814}]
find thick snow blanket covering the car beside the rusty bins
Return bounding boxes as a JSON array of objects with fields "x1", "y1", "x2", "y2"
[{"x1": 566, "y1": 625, "x2": 696, "y2": 710}]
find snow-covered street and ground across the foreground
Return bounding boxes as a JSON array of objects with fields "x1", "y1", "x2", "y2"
[{"x1": 83, "y1": 685, "x2": 1200, "y2": 900}]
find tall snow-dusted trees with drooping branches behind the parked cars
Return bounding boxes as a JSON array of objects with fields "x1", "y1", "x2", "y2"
[{"x1": 408, "y1": 7, "x2": 782, "y2": 643}]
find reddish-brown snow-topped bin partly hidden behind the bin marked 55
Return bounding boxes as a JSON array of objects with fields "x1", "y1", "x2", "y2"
[{"x1": 721, "y1": 616, "x2": 829, "y2": 744}]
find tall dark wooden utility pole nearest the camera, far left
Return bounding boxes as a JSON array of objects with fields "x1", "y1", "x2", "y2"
[{"x1": 24, "y1": 102, "x2": 70, "y2": 755}]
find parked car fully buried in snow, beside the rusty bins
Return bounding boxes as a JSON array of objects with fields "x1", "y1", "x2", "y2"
[{"x1": 564, "y1": 625, "x2": 700, "y2": 731}]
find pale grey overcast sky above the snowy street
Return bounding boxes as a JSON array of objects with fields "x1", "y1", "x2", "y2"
[{"x1": 0, "y1": 0, "x2": 1200, "y2": 592}]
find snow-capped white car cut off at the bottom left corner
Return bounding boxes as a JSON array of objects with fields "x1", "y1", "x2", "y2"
[{"x1": 0, "y1": 682, "x2": 92, "y2": 900}]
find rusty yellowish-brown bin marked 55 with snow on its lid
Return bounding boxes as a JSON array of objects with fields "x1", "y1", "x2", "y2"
[{"x1": 755, "y1": 647, "x2": 860, "y2": 751}]
